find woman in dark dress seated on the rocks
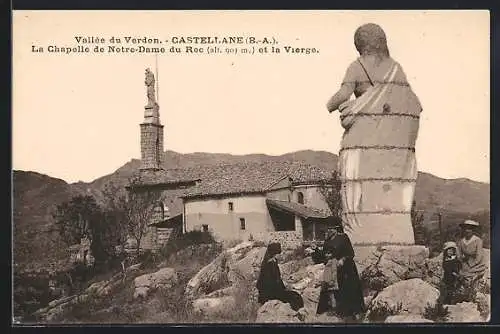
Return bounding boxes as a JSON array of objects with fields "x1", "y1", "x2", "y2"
[{"x1": 257, "y1": 242, "x2": 304, "y2": 311}]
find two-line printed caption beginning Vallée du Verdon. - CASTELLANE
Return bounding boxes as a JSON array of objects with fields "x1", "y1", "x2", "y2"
[{"x1": 31, "y1": 36, "x2": 319, "y2": 55}]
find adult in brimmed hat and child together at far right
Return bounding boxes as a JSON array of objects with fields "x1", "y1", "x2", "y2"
[{"x1": 440, "y1": 220, "x2": 487, "y2": 304}]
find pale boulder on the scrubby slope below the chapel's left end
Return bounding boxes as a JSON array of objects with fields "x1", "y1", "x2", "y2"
[{"x1": 134, "y1": 268, "x2": 177, "y2": 298}]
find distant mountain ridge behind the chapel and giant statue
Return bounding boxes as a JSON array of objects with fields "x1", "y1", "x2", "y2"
[{"x1": 13, "y1": 150, "x2": 490, "y2": 263}]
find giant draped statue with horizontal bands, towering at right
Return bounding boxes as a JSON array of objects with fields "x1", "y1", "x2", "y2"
[{"x1": 327, "y1": 23, "x2": 422, "y2": 244}]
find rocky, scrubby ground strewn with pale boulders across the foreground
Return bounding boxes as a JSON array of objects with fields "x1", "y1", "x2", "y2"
[{"x1": 35, "y1": 242, "x2": 491, "y2": 324}]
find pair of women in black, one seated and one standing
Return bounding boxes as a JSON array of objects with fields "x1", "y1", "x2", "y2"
[{"x1": 257, "y1": 224, "x2": 365, "y2": 319}]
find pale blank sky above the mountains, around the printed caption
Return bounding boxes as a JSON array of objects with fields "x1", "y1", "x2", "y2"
[{"x1": 13, "y1": 11, "x2": 490, "y2": 182}]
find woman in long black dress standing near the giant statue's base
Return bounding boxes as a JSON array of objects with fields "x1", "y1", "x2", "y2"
[{"x1": 318, "y1": 224, "x2": 365, "y2": 318}]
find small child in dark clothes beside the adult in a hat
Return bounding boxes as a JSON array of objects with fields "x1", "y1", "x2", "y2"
[{"x1": 439, "y1": 241, "x2": 461, "y2": 305}]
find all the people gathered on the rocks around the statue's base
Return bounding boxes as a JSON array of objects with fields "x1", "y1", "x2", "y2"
[{"x1": 257, "y1": 220, "x2": 487, "y2": 320}]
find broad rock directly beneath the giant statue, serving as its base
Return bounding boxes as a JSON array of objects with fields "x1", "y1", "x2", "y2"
[{"x1": 358, "y1": 245, "x2": 429, "y2": 291}]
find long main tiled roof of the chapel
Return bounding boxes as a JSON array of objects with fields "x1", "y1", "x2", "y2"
[{"x1": 183, "y1": 162, "x2": 331, "y2": 198}]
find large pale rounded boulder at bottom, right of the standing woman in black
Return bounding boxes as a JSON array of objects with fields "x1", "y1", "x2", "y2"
[{"x1": 368, "y1": 278, "x2": 439, "y2": 316}]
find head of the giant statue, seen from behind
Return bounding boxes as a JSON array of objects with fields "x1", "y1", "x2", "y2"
[{"x1": 354, "y1": 23, "x2": 389, "y2": 57}]
